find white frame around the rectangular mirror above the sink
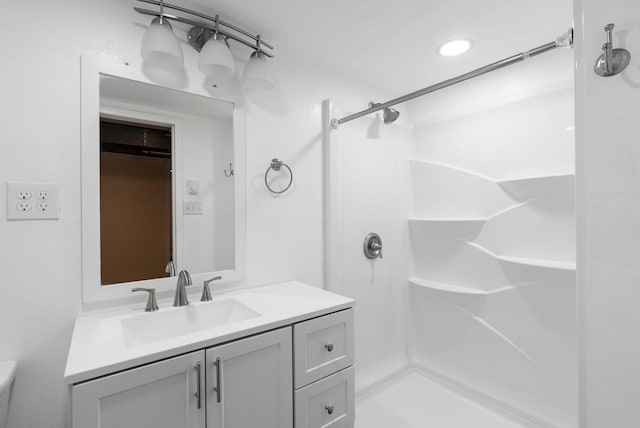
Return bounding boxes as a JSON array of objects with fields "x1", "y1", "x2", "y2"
[{"x1": 80, "y1": 56, "x2": 247, "y2": 305}]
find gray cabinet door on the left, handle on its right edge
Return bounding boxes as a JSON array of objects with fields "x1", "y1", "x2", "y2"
[{"x1": 71, "y1": 351, "x2": 205, "y2": 428}]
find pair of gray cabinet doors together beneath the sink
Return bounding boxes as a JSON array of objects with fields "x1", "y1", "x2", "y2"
[{"x1": 72, "y1": 327, "x2": 293, "y2": 428}]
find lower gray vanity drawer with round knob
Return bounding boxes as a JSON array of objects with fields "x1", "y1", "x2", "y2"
[{"x1": 294, "y1": 367, "x2": 355, "y2": 428}]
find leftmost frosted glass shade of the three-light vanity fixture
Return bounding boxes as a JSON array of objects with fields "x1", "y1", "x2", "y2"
[{"x1": 140, "y1": 18, "x2": 184, "y2": 69}]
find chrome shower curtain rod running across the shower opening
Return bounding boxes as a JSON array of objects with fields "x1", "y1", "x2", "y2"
[{"x1": 331, "y1": 28, "x2": 573, "y2": 129}]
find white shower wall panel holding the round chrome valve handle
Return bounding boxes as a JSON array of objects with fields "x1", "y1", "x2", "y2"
[{"x1": 324, "y1": 102, "x2": 408, "y2": 391}]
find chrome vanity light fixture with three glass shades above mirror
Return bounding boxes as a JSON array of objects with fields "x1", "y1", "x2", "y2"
[{"x1": 133, "y1": 0, "x2": 275, "y2": 92}]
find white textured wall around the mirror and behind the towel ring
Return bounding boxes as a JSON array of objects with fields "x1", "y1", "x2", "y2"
[{"x1": 0, "y1": 0, "x2": 380, "y2": 428}]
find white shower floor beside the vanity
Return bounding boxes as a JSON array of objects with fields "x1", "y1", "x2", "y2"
[{"x1": 355, "y1": 369, "x2": 535, "y2": 428}]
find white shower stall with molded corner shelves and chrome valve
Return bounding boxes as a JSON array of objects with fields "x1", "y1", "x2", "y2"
[{"x1": 324, "y1": 27, "x2": 578, "y2": 428}]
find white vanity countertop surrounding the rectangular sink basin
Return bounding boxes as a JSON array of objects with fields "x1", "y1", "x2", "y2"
[{"x1": 64, "y1": 281, "x2": 355, "y2": 384}]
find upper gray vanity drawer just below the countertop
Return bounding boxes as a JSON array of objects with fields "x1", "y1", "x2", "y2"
[{"x1": 293, "y1": 309, "x2": 353, "y2": 389}]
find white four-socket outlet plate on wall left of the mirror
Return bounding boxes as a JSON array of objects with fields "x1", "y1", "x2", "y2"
[{"x1": 7, "y1": 183, "x2": 60, "y2": 220}]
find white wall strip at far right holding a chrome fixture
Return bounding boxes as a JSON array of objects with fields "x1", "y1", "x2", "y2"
[{"x1": 574, "y1": 0, "x2": 640, "y2": 428}]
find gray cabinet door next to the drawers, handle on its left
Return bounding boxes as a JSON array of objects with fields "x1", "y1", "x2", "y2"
[{"x1": 207, "y1": 327, "x2": 293, "y2": 428}]
